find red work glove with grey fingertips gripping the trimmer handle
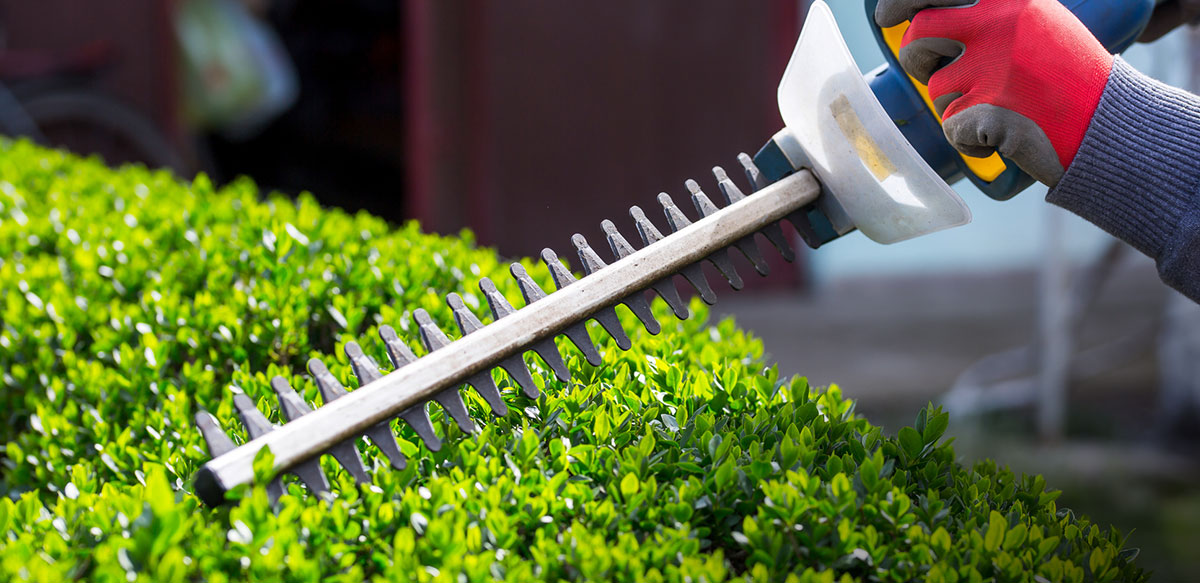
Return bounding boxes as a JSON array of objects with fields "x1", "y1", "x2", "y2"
[{"x1": 876, "y1": 0, "x2": 1113, "y2": 186}]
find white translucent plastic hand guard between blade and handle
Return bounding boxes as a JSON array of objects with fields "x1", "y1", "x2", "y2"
[{"x1": 776, "y1": 0, "x2": 972, "y2": 243}]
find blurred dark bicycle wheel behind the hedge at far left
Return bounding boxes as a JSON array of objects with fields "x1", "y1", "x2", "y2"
[{"x1": 20, "y1": 89, "x2": 187, "y2": 174}]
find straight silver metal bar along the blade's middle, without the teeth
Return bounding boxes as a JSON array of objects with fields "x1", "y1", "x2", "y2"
[{"x1": 195, "y1": 165, "x2": 820, "y2": 505}]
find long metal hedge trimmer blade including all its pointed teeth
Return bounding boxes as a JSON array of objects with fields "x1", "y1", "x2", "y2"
[{"x1": 195, "y1": 154, "x2": 820, "y2": 506}]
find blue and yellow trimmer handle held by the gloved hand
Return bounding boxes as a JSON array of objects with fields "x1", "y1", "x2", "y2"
[{"x1": 864, "y1": 0, "x2": 1157, "y2": 201}]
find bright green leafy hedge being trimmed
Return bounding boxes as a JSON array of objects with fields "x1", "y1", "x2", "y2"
[{"x1": 0, "y1": 142, "x2": 1146, "y2": 583}]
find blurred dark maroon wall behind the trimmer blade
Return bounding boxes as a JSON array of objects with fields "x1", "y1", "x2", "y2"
[{"x1": 405, "y1": 0, "x2": 800, "y2": 285}]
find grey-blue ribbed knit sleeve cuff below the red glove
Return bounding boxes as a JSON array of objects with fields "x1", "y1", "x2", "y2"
[{"x1": 1047, "y1": 58, "x2": 1201, "y2": 302}]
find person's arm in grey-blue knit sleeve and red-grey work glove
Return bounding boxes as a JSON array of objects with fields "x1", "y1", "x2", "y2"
[{"x1": 876, "y1": 0, "x2": 1201, "y2": 302}]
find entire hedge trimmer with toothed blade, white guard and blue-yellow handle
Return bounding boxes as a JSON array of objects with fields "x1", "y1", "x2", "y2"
[{"x1": 195, "y1": 0, "x2": 1146, "y2": 505}]
